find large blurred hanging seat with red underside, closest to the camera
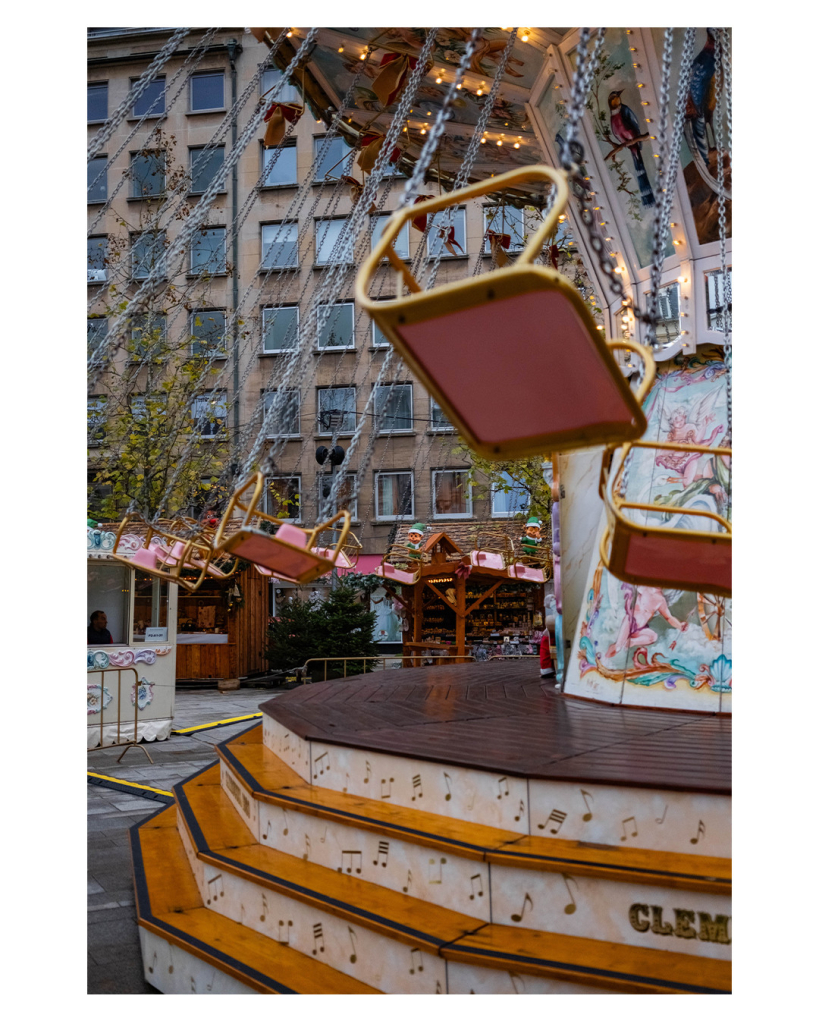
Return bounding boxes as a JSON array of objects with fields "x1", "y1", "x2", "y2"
[{"x1": 355, "y1": 166, "x2": 654, "y2": 461}]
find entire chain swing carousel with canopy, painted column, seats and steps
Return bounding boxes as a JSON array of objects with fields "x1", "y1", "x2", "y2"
[{"x1": 116, "y1": 29, "x2": 731, "y2": 994}]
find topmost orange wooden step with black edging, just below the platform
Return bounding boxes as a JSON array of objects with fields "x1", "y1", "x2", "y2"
[{"x1": 217, "y1": 725, "x2": 731, "y2": 896}]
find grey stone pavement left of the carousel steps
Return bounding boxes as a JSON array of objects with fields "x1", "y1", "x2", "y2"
[{"x1": 87, "y1": 688, "x2": 278, "y2": 994}]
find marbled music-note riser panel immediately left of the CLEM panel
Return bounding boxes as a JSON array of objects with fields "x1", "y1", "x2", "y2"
[{"x1": 259, "y1": 804, "x2": 489, "y2": 921}]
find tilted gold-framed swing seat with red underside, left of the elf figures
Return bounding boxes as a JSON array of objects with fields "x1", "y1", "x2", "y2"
[{"x1": 214, "y1": 472, "x2": 350, "y2": 584}]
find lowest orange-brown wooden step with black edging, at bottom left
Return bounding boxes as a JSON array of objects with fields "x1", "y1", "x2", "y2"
[{"x1": 131, "y1": 807, "x2": 378, "y2": 994}]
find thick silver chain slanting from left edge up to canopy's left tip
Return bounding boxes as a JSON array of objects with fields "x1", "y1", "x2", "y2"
[{"x1": 88, "y1": 28, "x2": 317, "y2": 389}]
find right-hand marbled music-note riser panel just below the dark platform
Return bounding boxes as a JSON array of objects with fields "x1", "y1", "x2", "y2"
[{"x1": 529, "y1": 779, "x2": 731, "y2": 857}]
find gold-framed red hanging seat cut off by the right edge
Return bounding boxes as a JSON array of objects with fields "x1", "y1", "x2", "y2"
[{"x1": 600, "y1": 441, "x2": 731, "y2": 597}]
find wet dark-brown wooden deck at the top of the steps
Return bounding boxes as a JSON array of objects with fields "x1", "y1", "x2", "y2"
[{"x1": 261, "y1": 660, "x2": 731, "y2": 795}]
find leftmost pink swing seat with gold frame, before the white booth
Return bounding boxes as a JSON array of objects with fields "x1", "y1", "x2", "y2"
[{"x1": 112, "y1": 515, "x2": 213, "y2": 592}]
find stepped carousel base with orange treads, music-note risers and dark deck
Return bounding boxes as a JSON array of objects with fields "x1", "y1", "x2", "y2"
[{"x1": 132, "y1": 665, "x2": 731, "y2": 994}]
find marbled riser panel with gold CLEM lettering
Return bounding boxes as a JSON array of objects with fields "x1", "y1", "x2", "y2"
[{"x1": 491, "y1": 865, "x2": 731, "y2": 959}]
